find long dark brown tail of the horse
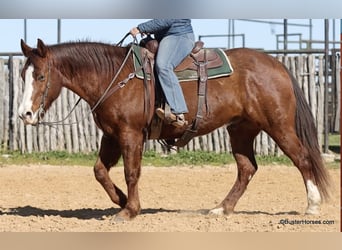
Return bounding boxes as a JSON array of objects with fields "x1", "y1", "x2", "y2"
[{"x1": 288, "y1": 71, "x2": 331, "y2": 199}]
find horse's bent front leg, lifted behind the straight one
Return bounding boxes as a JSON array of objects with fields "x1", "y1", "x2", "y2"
[{"x1": 94, "y1": 136, "x2": 127, "y2": 208}]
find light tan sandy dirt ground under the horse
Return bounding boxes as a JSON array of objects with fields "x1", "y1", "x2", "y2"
[{"x1": 0, "y1": 165, "x2": 341, "y2": 232}]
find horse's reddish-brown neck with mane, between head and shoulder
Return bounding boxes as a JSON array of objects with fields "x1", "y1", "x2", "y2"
[{"x1": 54, "y1": 43, "x2": 128, "y2": 106}]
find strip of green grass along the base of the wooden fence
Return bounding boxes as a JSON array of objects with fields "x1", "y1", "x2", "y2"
[{"x1": 0, "y1": 150, "x2": 292, "y2": 166}]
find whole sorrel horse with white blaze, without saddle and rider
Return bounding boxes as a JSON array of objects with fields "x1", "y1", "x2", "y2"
[{"x1": 19, "y1": 39, "x2": 329, "y2": 219}]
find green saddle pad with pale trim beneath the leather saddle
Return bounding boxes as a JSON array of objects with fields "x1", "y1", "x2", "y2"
[{"x1": 133, "y1": 45, "x2": 234, "y2": 82}]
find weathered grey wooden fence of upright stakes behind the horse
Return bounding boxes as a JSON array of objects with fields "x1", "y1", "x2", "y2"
[{"x1": 0, "y1": 55, "x2": 340, "y2": 155}]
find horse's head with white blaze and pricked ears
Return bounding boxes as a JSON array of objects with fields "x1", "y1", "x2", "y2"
[{"x1": 18, "y1": 39, "x2": 61, "y2": 125}]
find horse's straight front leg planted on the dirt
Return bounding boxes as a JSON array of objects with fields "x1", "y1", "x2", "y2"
[{"x1": 116, "y1": 131, "x2": 144, "y2": 220}]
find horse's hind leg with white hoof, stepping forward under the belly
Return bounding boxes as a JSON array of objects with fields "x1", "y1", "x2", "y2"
[{"x1": 210, "y1": 123, "x2": 260, "y2": 214}]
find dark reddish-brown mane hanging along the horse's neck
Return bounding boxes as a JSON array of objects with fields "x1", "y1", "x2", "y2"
[{"x1": 49, "y1": 41, "x2": 128, "y2": 76}]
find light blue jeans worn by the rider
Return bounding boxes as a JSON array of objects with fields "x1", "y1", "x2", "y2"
[{"x1": 156, "y1": 33, "x2": 195, "y2": 114}]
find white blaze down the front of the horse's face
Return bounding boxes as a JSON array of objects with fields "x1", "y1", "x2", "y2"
[{"x1": 18, "y1": 65, "x2": 34, "y2": 122}]
